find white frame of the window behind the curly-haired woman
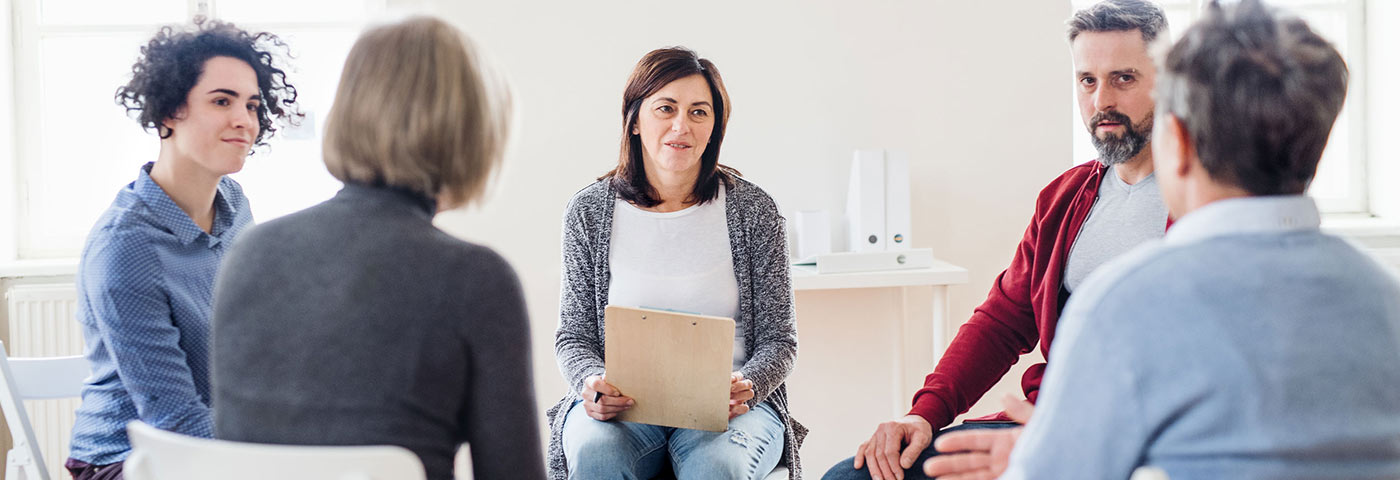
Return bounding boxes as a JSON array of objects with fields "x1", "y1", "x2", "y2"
[{"x1": 0, "y1": 0, "x2": 389, "y2": 264}]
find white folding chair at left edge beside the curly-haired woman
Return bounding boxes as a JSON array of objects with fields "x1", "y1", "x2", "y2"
[{"x1": 0, "y1": 341, "x2": 90, "y2": 480}]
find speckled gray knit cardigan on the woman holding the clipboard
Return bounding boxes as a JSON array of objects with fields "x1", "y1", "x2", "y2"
[{"x1": 547, "y1": 179, "x2": 806, "y2": 480}]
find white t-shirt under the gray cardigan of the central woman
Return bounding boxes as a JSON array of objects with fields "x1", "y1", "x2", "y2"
[{"x1": 608, "y1": 188, "x2": 749, "y2": 371}]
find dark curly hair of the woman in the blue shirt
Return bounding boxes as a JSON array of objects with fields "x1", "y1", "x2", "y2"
[{"x1": 115, "y1": 17, "x2": 302, "y2": 147}]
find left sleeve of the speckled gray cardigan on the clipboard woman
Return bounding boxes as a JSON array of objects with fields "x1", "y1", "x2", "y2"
[{"x1": 554, "y1": 190, "x2": 603, "y2": 393}]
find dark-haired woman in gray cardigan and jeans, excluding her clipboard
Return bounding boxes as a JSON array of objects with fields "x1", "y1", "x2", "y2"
[{"x1": 549, "y1": 48, "x2": 806, "y2": 480}]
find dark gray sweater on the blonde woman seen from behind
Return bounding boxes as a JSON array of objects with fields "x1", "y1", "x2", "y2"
[{"x1": 211, "y1": 183, "x2": 545, "y2": 480}]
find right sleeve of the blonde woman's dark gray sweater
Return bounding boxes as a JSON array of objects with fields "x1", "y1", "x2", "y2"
[{"x1": 462, "y1": 255, "x2": 545, "y2": 479}]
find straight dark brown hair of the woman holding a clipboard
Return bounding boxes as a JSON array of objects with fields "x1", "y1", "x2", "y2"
[{"x1": 599, "y1": 46, "x2": 739, "y2": 207}]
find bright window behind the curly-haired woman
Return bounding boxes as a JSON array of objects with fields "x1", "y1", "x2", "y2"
[{"x1": 0, "y1": 0, "x2": 384, "y2": 260}]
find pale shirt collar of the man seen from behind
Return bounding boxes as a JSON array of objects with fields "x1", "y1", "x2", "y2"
[{"x1": 1165, "y1": 195, "x2": 1322, "y2": 243}]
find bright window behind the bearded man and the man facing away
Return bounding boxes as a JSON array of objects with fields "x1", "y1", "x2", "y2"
[{"x1": 1071, "y1": 0, "x2": 1383, "y2": 217}]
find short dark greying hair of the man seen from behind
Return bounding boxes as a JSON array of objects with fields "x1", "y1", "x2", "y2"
[{"x1": 1156, "y1": 0, "x2": 1348, "y2": 195}]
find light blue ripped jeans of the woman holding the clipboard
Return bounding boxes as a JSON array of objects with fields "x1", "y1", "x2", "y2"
[{"x1": 564, "y1": 400, "x2": 784, "y2": 480}]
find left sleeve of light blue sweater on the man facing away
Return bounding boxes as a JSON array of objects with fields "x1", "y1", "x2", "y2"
[{"x1": 1002, "y1": 258, "x2": 1148, "y2": 479}]
